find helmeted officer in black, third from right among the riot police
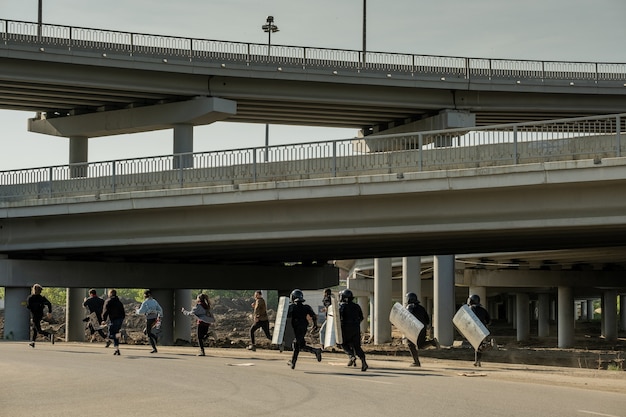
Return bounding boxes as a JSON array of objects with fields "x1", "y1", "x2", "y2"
[{"x1": 339, "y1": 289, "x2": 369, "y2": 372}]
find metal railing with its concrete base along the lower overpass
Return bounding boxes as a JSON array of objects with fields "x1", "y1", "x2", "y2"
[{"x1": 0, "y1": 113, "x2": 626, "y2": 202}]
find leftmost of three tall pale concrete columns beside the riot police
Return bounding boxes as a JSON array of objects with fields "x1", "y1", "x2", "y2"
[{"x1": 374, "y1": 258, "x2": 391, "y2": 345}]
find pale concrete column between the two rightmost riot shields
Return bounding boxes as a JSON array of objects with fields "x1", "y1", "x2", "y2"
[{"x1": 432, "y1": 255, "x2": 455, "y2": 346}]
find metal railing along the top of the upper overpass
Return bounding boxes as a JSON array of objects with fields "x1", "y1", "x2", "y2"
[{"x1": 0, "y1": 19, "x2": 626, "y2": 83}]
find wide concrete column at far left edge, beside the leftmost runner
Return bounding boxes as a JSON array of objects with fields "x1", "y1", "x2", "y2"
[{"x1": 4, "y1": 287, "x2": 30, "y2": 340}]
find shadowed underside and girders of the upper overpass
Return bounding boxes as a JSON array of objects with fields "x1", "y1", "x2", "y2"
[{"x1": 0, "y1": 54, "x2": 626, "y2": 137}]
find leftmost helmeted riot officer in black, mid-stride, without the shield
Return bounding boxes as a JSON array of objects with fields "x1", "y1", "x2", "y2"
[{"x1": 287, "y1": 290, "x2": 322, "y2": 369}]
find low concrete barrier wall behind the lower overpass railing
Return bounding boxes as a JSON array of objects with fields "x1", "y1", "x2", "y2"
[{"x1": 0, "y1": 135, "x2": 617, "y2": 202}]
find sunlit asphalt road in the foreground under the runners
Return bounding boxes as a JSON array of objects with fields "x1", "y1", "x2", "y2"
[{"x1": 0, "y1": 342, "x2": 626, "y2": 417}]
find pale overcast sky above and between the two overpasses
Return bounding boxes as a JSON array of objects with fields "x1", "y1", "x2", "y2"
[{"x1": 0, "y1": 0, "x2": 626, "y2": 171}]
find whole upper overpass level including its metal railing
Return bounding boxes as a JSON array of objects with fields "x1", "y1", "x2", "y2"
[{"x1": 0, "y1": 20, "x2": 626, "y2": 137}]
